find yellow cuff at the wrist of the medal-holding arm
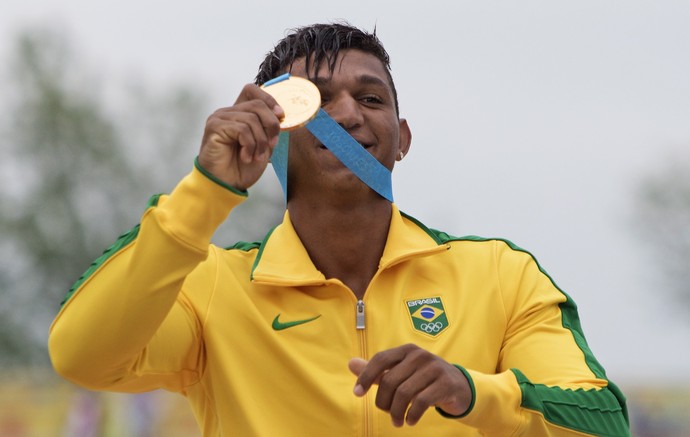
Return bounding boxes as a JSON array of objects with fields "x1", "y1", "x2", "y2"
[{"x1": 154, "y1": 161, "x2": 247, "y2": 250}]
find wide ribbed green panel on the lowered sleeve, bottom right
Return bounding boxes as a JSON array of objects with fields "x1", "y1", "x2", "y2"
[{"x1": 511, "y1": 369, "x2": 630, "y2": 437}]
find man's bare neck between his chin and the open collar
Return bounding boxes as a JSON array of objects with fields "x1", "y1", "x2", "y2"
[{"x1": 288, "y1": 198, "x2": 392, "y2": 298}]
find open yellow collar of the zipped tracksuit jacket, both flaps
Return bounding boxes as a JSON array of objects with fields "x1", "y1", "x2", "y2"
[{"x1": 252, "y1": 204, "x2": 447, "y2": 286}]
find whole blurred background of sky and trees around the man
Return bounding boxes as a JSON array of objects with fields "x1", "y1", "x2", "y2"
[{"x1": 0, "y1": 0, "x2": 690, "y2": 437}]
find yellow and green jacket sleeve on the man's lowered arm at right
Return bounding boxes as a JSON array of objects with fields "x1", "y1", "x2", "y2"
[{"x1": 446, "y1": 241, "x2": 630, "y2": 437}]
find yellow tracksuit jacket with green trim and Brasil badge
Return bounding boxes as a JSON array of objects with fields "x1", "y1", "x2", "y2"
[{"x1": 49, "y1": 168, "x2": 629, "y2": 437}]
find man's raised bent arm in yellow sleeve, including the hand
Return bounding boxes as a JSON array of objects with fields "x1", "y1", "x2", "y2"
[{"x1": 49, "y1": 85, "x2": 282, "y2": 391}]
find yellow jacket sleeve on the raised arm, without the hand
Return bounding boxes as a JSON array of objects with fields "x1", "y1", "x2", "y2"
[{"x1": 48, "y1": 163, "x2": 246, "y2": 392}]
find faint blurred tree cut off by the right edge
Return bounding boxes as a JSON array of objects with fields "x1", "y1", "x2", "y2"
[{"x1": 635, "y1": 152, "x2": 690, "y2": 308}]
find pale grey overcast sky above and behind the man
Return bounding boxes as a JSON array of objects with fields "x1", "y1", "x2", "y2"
[{"x1": 0, "y1": 0, "x2": 690, "y2": 385}]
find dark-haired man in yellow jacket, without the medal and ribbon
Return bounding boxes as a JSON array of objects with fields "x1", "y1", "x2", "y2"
[{"x1": 49, "y1": 24, "x2": 628, "y2": 436}]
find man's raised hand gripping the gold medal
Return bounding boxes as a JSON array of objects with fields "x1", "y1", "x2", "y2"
[{"x1": 199, "y1": 84, "x2": 284, "y2": 190}]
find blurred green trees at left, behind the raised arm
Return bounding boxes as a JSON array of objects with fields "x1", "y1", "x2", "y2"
[{"x1": 0, "y1": 29, "x2": 283, "y2": 366}]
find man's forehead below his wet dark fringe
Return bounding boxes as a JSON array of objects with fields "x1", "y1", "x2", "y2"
[{"x1": 289, "y1": 49, "x2": 390, "y2": 83}]
